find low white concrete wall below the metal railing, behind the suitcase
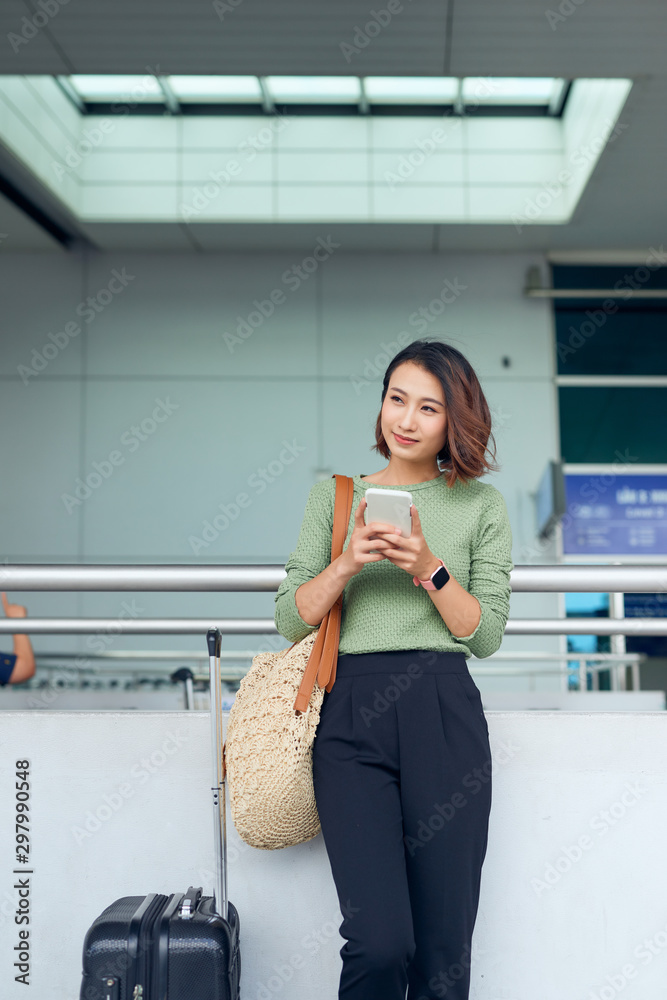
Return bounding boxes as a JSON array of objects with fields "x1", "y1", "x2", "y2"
[{"x1": 0, "y1": 712, "x2": 667, "y2": 1000}]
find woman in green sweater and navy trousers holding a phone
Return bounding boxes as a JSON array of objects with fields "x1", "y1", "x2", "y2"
[{"x1": 275, "y1": 340, "x2": 513, "y2": 1000}]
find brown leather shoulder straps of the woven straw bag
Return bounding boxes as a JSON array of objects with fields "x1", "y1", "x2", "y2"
[{"x1": 294, "y1": 473, "x2": 354, "y2": 712}]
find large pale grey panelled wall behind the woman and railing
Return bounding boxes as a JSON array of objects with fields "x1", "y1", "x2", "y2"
[{"x1": 0, "y1": 246, "x2": 559, "y2": 689}]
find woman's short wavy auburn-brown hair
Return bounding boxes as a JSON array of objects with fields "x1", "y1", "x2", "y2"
[{"x1": 371, "y1": 339, "x2": 499, "y2": 486}]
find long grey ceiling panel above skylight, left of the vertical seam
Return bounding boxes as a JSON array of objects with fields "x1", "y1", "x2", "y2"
[{"x1": 40, "y1": 0, "x2": 446, "y2": 75}]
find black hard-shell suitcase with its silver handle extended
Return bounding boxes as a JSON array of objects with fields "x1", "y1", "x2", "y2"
[{"x1": 80, "y1": 628, "x2": 241, "y2": 1000}]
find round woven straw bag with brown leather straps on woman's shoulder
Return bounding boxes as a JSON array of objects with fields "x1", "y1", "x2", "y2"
[{"x1": 223, "y1": 475, "x2": 354, "y2": 851}]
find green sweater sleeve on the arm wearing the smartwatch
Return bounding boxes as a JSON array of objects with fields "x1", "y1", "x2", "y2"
[{"x1": 457, "y1": 488, "x2": 514, "y2": 658}]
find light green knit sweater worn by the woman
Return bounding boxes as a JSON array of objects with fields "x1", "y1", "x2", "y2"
[{"x1": 275, "y1": 475, "x2": 513, "y2": 657}]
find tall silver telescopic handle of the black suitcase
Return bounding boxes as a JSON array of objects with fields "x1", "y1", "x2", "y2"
[{"x1": 206, "y1": 627, "x2": 228, "y2": 920}]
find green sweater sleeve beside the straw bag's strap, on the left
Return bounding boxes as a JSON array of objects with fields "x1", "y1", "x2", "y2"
[{"x1": 274, "y1": 478, "x2": 334, "y2": 642}]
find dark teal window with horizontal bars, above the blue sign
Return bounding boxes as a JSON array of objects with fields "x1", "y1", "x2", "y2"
[{"x1": 553, "y1": 262, "x2": 667, "y2": 463}]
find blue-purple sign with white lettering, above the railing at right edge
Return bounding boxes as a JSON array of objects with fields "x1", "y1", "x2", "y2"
[{"x1": 562, "y1": 471, "x2": 667, "y2": 557}]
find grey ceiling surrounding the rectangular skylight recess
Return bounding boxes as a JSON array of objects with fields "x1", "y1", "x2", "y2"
[{"x1": 0, "y1": 0, "x2": 667, "y2": 252}]
